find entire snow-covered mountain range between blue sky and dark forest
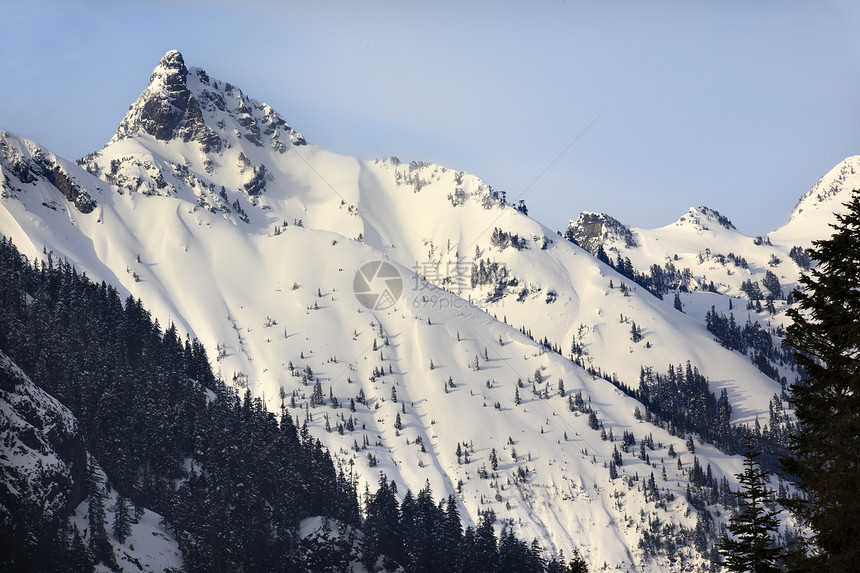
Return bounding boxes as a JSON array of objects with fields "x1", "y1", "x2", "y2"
[{"x1": 0, "y1": 51, "x2": 840, "y2": 571}]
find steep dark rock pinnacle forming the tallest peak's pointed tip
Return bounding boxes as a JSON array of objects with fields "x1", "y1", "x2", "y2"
[{"x1": 111, "y1": 50, "x2": 221, "y2": 153}]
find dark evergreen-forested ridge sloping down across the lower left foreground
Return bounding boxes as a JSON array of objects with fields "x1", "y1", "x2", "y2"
[{"x1": 0, "y1": 238, "x2": 585, "y2": 571}]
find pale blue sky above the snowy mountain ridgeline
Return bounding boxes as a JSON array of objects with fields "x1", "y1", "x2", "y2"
[{"x1": 0, "y1": 0, "x2": 860, "y2": 234}]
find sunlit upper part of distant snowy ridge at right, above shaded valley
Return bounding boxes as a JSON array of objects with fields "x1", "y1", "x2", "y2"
[{"x1": 566, "y1": 156, "x2": 860, "y2": 304}]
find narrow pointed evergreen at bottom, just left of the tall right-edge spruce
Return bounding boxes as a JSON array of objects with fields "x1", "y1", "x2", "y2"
[{"x1": 716, "y1": 434, "x2": 781, "y2": 573}]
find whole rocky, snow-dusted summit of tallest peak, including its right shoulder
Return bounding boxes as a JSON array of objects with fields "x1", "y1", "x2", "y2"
[{"x1": 89, "y1": 50, "x2": 307, "y2": 203}]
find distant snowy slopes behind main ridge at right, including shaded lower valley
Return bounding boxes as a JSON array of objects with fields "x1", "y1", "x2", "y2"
[{"x1": 565, "y1": 161, "x2": 860, "y2": 388}]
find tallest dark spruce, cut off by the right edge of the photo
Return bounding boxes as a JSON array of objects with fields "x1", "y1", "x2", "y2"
[{"x1": 782, "y1": 190, "x2": 860, "y2": 571}]
